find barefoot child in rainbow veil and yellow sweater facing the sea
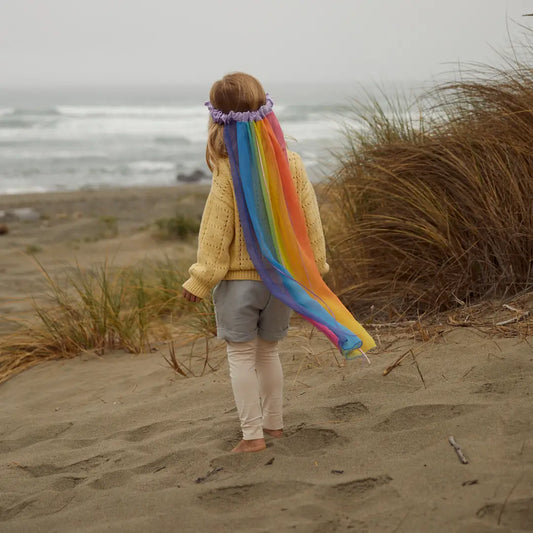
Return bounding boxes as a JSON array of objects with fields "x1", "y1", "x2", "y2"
[{"x1": 183, "y1": 72, "x2": 372, "y2": 452}]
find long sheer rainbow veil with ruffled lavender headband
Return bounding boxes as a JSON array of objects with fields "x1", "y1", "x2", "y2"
[{"x1": 206, "y1": 94, "x2": 375, "y2": 359}]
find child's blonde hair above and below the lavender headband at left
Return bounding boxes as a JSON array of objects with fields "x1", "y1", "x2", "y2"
[{"x1": 205, "y1": 72, "x2": 266, "y2": 171}]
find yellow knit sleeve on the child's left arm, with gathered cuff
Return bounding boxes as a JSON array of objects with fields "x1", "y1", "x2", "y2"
[{"x1": 183, "y1": 162, "x2": 235, "y2": 298}]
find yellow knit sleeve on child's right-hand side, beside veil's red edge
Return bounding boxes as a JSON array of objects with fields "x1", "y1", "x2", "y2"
[{"x1": 290, "y1": 152, "x2": 329, "y2": 276}]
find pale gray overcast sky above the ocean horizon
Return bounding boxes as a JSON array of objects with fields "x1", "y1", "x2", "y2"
[{"x1": 0, "y1": 0, "x2": 533, "y2": 87}]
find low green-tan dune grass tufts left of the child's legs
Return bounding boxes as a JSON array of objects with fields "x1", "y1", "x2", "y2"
[{"x1": 0, "y1": 259, "x2": 212, "y2": 383}]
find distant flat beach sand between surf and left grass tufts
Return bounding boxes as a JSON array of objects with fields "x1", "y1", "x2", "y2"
[{"x1": 0, "y1": 185, "x2": 209, "y2": 334}]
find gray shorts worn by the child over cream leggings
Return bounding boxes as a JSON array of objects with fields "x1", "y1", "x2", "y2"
[{"x1": 213, "y1": 279, "x2": 292, "y2": 342}]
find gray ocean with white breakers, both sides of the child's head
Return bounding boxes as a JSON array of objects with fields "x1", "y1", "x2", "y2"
[{"x1": 0, "y1": 81, "x2": 416, "y2": 194}]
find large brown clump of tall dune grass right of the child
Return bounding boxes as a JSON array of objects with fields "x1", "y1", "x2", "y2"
[{"x1": 324, "y1": 55, "x2": 533, "y2": 319}]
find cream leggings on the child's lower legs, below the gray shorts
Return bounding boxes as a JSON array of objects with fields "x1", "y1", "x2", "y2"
[{"x1": 228, "y1": 337, "x2": 283, "y2": 440}]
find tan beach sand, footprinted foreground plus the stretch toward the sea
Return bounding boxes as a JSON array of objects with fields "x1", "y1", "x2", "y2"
[{"x1": 0, "y1": 185, "x2": 533, "y2": 533}]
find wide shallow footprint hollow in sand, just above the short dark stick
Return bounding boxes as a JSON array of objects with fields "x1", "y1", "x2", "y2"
[{"x1": 373, "y1": 404, "x2": 479, "y2": 431}]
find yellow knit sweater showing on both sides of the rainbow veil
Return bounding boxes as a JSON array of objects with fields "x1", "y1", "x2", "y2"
[{"x1": 183, "y1": 152, "x2": 329, "y2": 298}]
